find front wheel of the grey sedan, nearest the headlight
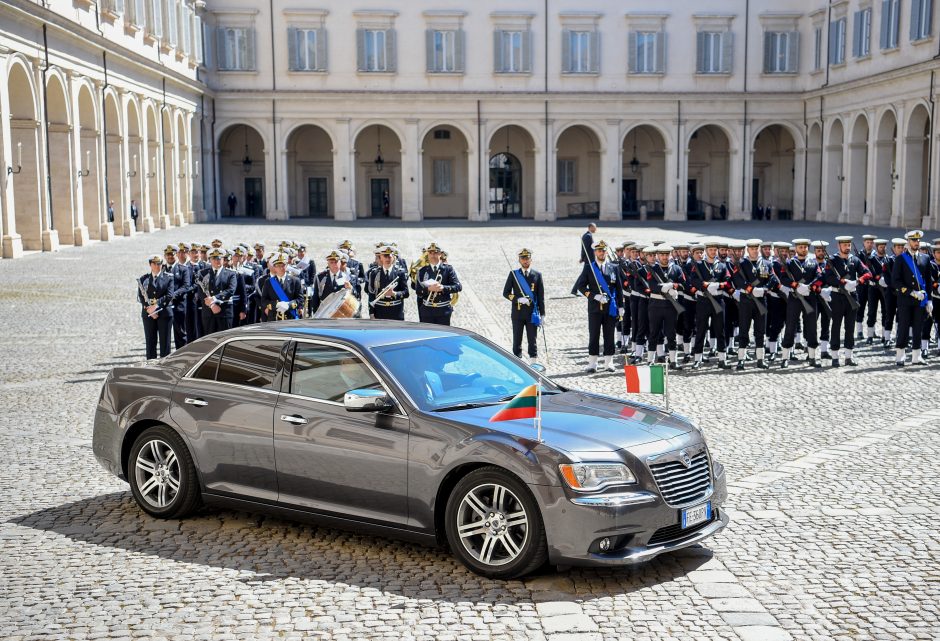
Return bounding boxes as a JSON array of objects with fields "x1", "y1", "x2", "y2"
[{"x1": 444, "y1": 466, "x2": 548, "y2": 579}]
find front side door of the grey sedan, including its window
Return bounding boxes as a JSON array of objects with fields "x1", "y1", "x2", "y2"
[{"x1": 274, "y1": 341, "x2": 409, "y2": 525}]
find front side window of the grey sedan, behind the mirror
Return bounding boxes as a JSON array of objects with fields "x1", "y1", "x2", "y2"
[{"x1": 290, "y1": 343, "x2": 383, "y2": 403}]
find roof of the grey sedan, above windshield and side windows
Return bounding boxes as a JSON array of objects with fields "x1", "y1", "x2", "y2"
[{"x1": 226, "y1": 319, "x2": 472, "y2": 349}]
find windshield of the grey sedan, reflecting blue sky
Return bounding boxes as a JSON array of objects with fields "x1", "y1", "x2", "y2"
[{"x1": 373, "y1": 336, "x2": 558, "y2": 411}]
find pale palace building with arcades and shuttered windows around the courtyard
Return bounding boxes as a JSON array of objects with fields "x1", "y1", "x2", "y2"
[{"x1": 0, "y1": 0, "x2": 940, "y2": 257}]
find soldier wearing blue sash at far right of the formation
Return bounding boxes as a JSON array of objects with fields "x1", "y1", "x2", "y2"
[{"x1": 891, "y1": 230, "x2": 933, "y2": 367}]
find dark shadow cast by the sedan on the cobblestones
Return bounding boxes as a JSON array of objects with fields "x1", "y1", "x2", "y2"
[{"x1": 9, "y1": 492, "x2": 712, "y2": 604}]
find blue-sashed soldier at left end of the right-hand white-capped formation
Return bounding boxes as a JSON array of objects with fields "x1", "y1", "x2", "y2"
[{"x1": 575, "y1": 241, "x2": 620, "y2": 372}]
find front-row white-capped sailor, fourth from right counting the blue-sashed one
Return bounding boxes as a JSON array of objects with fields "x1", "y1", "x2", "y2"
[{"x1": 732, "y1": 238, "x2": 780, "y2": 370}]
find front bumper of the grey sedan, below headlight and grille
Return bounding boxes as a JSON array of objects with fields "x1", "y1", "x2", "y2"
[{"x1": 530, "y1": 466, "x2": 730, "y2": 566}]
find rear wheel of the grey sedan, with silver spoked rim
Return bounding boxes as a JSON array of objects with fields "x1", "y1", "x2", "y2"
[{"x1": 127, "y1": 425, "x2": 201, "y2": 519}]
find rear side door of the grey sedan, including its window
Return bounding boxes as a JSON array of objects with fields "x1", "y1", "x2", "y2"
[{"x1": 170, "y1": 339, "x2": 286, "y2": 502}]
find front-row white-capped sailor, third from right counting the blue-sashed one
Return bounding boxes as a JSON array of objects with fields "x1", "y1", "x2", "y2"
[{"x1": 779, "y1": 238, "x2": 823, "y2": 369}]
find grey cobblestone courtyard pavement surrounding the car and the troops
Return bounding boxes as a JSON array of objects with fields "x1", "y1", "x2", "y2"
[{"x1": 0, "y1": 222, "x2": 940, "y2": 641}]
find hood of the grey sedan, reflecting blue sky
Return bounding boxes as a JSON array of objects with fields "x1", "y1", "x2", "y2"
[{"x1": 434, "y1": 391, "x2": 694, "y2": 452}]
